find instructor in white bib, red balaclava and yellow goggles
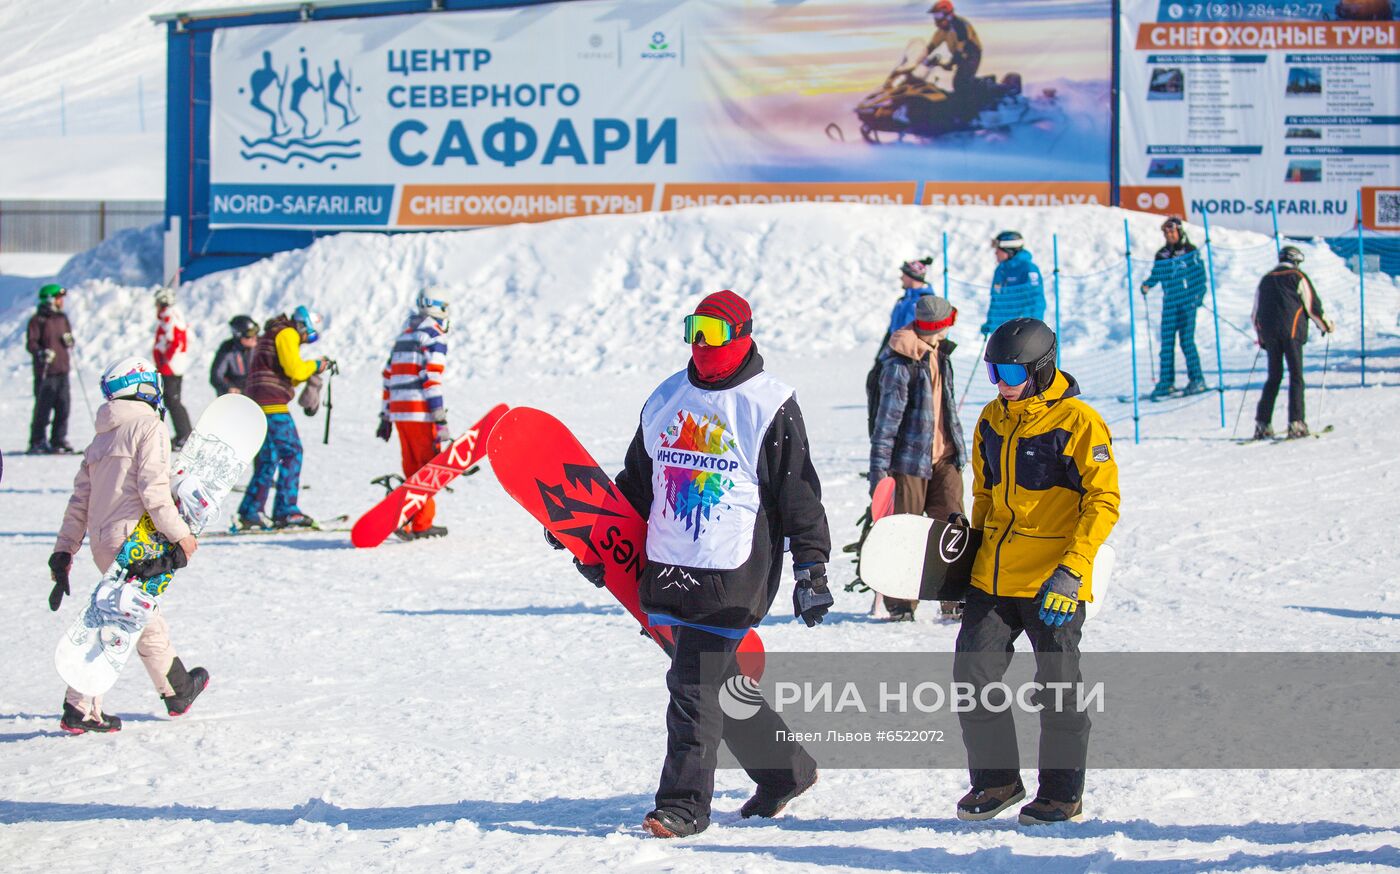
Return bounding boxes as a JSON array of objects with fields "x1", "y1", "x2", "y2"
[{"x1": 548, "y1": 290, "x2": 833, "y2": 838}]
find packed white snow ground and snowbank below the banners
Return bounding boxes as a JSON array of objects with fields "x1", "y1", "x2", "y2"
[{"x1": 0, "y1": 206, "x2": 1400, "y2": 873}]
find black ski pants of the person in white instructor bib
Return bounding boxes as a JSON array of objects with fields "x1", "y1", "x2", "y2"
[{"x1": 657, "y1": 625, "x2": 816, "y2": 825}]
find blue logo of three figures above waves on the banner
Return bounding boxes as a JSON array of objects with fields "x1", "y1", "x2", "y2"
[{"x1": 238, "y1": 46, "x2": 361, "y2": 169}]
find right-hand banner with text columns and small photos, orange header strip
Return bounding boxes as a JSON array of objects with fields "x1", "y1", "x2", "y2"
[{"x1": 1119, "y1": 0, "x2": 1400, "y2": 235}]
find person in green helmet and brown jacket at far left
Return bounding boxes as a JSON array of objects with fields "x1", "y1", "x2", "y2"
[{"x1": 24, "y1": 283, "x2": 73, "y2": 455}]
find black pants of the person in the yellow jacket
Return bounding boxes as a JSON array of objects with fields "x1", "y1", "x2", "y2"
[{"x1": 953, "y1": 587, "x2": 1089, "y2": 801}]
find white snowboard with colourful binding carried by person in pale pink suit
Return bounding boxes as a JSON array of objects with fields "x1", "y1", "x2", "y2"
[{"x1": 53, "y1": 395, "x2": 267, "y2": 695}]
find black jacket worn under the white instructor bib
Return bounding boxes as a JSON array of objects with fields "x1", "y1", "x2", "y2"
[{"x1": 616, "y1": 347, "x2": 832, "y2": 629}]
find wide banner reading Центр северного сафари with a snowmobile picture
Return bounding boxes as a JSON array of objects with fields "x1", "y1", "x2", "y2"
[{"x1": 210, "y1": 0, "x2": 1112, "y2": 228}]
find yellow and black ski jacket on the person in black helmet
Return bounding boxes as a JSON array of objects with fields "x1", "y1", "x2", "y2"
[{"x1": 972, "y1": 371, "x2": 1119, "y2": 601}]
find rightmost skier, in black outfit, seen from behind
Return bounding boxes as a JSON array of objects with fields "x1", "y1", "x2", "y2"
[{"x1": 1250, "y1": 247, "x2": 1336, "y2": 440}]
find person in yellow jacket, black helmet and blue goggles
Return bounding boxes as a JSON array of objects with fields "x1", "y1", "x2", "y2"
[{"x1": 953, "y1": 318, "x2": 1119, "y2": 825}]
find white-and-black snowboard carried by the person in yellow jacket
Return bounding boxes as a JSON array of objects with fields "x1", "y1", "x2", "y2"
[{"x1": 860, "y1": 514, "x2": 1117, "y2": 619}]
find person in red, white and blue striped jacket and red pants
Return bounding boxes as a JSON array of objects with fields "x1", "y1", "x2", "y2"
[{"x1": 375, "y1": 290, "x2": 452, "y2": 539}]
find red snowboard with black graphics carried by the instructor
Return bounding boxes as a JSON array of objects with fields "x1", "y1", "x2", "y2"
[{"x1": 486, "y1": 406, "x2": 763, "y2": 678}]
